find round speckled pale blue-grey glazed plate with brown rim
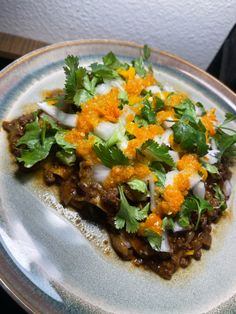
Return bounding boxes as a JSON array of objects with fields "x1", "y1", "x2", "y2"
[{"x1": 0, "y1": 40, "x2": 236, "y2": 314}]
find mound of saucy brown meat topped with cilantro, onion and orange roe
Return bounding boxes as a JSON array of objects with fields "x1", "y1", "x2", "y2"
[{"x1": 3, "y1": 46, "x2": 236, "y2": 279}]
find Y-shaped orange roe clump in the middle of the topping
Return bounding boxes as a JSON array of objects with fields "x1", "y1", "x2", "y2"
[{"x1": 124, "y1": 122, "x2": 164, "y2": 158}]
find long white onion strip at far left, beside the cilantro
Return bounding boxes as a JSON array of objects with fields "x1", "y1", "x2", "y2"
[{"x1": 38, "y1": 102, "x2": 77, "y2": 128}]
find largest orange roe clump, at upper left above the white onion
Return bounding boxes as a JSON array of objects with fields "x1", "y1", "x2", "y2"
[{"x1": 77, "y1": 88, "x2": 121, "y2": 133}]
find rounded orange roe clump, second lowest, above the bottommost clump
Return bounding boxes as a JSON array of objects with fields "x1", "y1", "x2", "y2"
[{"x1": 160, "y1": 185, "x2": 184, "y2": 215}]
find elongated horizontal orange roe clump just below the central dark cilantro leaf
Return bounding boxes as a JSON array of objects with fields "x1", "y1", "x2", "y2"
[{"x1": 104, "y1": 163, "x2": 151, "y2": 188}]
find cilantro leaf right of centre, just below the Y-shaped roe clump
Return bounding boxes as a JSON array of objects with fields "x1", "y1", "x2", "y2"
[{"x1": 140, "y1": 140, "x2": 175, "y2": 166}]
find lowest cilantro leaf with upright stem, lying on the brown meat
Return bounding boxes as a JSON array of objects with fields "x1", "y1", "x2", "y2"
[{"x1": 114, "y1": 187, "x2": 149, "y2": 233}]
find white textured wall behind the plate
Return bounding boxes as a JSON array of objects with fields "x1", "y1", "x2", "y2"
[{"x1": 0, "y1": 0, "x2": 236, "y2": 68}]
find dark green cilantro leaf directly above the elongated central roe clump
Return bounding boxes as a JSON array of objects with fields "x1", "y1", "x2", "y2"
[{"x1": 93, "y1": 142, "x2": 129, "y2": 168}]
